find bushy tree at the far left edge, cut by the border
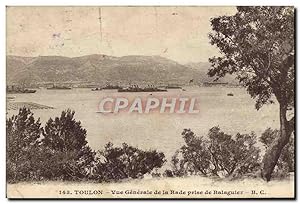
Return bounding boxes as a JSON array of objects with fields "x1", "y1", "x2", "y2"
[{"x1": 6, "y1": 108, "x2": 42, "y2": 182}]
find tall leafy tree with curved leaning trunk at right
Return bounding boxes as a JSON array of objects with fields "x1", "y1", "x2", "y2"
[{"x1": 208, "y1": 7, "x2": 295, "y2": 181}]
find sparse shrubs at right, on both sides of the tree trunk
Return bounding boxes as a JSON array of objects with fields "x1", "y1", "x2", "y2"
[{"x1": 164, "y1": 127, "x2": 294, "y2": 178}]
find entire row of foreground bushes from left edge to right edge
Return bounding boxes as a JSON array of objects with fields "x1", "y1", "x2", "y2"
[{"x1": 6, "y1": 108, "x2": 294, "y2": 183}]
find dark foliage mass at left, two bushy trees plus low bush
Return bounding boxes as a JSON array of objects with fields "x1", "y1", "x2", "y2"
[{"x1": 6, "y1": 108, "x2": 165, "y2": 182}]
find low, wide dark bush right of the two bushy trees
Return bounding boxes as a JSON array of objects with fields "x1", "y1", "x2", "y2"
[{"x1": 93, "y1": 143, "x2": 165, "y2": 181}]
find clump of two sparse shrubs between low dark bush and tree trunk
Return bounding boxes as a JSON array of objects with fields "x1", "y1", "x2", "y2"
[{"x1": 170, "y1": 127, "x2": 260, "y2": 177}]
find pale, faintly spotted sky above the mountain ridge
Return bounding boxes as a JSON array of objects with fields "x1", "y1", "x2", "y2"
[{"x1": 6, "y1": 7, "x2": 236, "y2": 63}]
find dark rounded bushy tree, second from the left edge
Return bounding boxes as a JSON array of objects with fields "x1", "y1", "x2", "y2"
[{"x1": 41, "y1": 110, "x2": 95, "y2": 180}]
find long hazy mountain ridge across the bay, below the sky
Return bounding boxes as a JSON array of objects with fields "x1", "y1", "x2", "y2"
[{"x1": 7, "y1": 54, "x2": 234, "y2": 85}]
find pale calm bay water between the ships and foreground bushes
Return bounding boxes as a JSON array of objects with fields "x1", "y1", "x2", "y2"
[{"x1": 8, "y1": 87, "x2": 279, "y2": 164}]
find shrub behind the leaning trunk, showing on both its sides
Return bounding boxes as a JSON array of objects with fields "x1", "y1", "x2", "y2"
[{"x1": 259, "y1": 128, "x2": 295, "y2": 177}]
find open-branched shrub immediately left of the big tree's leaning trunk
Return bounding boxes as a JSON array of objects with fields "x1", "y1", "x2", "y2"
[{"x1": 208, "y1": 127, "x2": 260, "y2": 177}]
